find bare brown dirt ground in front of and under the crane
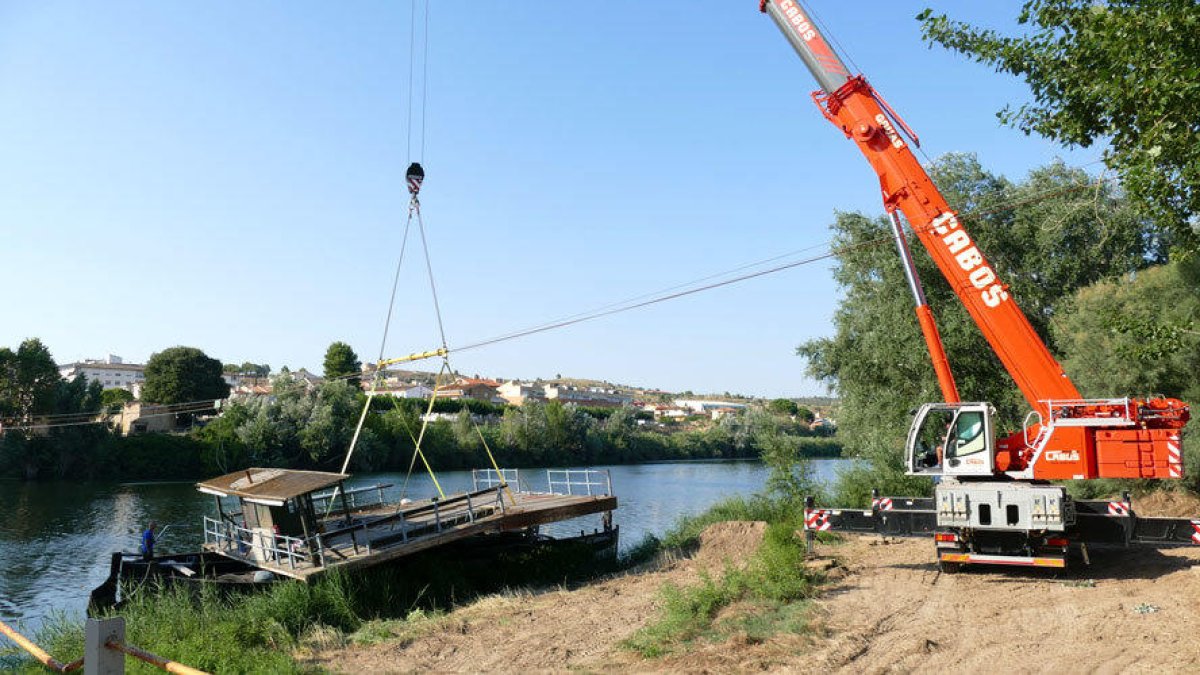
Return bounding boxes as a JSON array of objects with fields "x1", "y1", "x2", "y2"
[{"x1": 311, "y1": 501, "x2": 1200, "y2": 673}]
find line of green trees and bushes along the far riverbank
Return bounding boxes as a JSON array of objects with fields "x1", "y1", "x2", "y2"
[{"x1": 0, "y1": 340, "x2": 840, "y2": 479}]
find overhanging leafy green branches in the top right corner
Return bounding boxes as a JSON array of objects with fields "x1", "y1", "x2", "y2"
[{"x1": 917, "y1": 0, "x2": 1200, "y2": 251}]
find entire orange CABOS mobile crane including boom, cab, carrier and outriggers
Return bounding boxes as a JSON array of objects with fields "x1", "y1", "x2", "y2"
[{"x1": 760, "y1": 0, "x2": 1200, "y2": 569}]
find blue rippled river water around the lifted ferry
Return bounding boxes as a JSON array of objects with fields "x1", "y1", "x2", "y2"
[{"x1": 0, "y1": 460, "x2": 847, "y2": 629}]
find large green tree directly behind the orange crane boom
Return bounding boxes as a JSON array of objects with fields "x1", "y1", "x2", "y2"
[{"x1": 799, "y1": 155, "x2": 1165, "y2": 498}]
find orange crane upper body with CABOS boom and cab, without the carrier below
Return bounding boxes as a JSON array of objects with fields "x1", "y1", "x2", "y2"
[{"x1": 760, "y1": 0, "x2": 1189, "y2": 478}]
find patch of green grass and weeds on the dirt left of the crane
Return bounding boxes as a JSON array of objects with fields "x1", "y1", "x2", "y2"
[{"x1": 624, "y1": 496, "x2": 820, "y2": 658}]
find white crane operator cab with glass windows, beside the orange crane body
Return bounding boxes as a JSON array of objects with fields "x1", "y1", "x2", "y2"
[{"x1": 905, "y1": 404, "x2": 995, "y2": 476}]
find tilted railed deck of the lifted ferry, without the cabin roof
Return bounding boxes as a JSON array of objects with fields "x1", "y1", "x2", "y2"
[{"x1": 204, "y1": 470, "x2": 617, "y2": 580}]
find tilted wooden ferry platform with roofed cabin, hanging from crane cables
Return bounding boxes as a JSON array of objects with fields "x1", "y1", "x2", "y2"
[{"x1": 197, "y1": 468, "x2": 617, "y2": 580}]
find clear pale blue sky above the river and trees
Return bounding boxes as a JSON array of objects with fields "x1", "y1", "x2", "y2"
[{"x1": 0, "y1": 0, "x2": 1096, "y2": 396}]
